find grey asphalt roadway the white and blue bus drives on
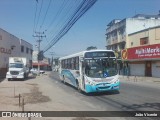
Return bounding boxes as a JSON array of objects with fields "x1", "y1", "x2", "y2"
[{"x1": 51, "y1": 72, "x2": 160, "y2": 120}]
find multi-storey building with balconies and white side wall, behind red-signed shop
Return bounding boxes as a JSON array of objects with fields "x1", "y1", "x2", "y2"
[{"x1": 106, "y1": 14, "x2": 160, "y2": 58}]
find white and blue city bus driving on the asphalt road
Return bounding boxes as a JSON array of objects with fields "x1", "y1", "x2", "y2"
[{"x1": 59, "y1": 50, "x2": 120, "y2": 93}]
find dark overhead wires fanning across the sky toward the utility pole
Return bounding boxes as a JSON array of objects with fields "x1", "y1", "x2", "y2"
[{"x1": 34, "y1": 0, "x2": 97, "y2": 53}]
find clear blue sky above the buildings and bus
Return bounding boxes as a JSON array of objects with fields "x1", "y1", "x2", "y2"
[{"x1": 0, "y1": 0, "x2": 160, "y2": 57}]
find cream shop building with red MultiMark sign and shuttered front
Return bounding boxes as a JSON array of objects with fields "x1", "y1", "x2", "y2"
[{"x1": 122, "y1": 26, "x2": 160, "y2": 77}]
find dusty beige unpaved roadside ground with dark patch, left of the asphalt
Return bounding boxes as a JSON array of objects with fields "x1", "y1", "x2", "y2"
[{"x1": 0, "y1": 72, "x2": 110, "y2": 120}]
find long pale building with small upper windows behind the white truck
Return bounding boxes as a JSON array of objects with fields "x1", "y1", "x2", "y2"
[{"x1": 0, "y1": 28, "x2": 33, "y2": 76}]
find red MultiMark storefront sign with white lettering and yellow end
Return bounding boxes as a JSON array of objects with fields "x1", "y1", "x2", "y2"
[{"x1": 122, "y1": 44, "x2": 160, "y2": 60}]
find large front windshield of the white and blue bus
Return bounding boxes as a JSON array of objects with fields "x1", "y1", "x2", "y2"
[{"x1": 84, "y1": 58, "x2": 117, "y2": 78}]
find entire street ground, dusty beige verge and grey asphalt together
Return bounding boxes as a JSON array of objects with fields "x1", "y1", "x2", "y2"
[{"x1": 0, "y1": 72, "x2": 160, "y2": 120}]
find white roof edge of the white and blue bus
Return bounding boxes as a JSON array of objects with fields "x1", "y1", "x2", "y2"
[{"x1": 59, "y1": 49, "x2": 114, "y2": 60}]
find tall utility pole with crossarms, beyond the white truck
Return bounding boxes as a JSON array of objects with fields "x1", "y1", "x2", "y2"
[{"x1": 33, "y1": 32, "x2": 46, "y2": 75}]
